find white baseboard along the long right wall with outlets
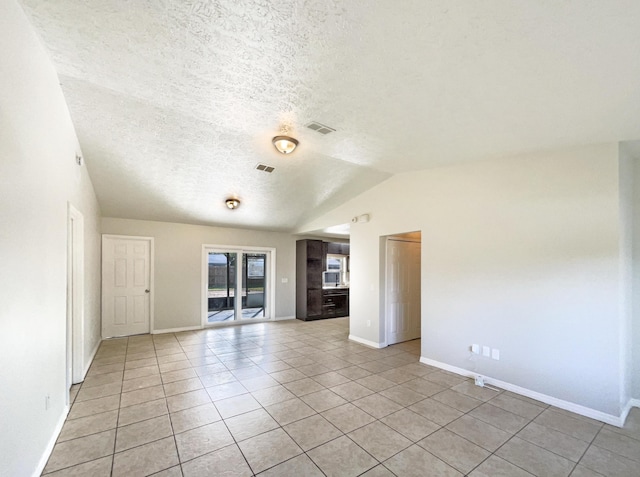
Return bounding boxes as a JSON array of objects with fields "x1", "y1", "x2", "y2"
[{"x1": 420, "y1": 357, "x2": 630, "y2": 427}]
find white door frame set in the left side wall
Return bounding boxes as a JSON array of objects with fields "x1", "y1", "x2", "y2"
[{"x1": 66, "y1": 203, "x2": 84, "y2": 392}]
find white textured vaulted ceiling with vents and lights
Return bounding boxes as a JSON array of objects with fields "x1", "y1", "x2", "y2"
[{"x1": 21, "y1": 0, "x2": 640, "y2": 230}]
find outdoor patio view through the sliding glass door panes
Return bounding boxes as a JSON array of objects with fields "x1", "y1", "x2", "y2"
[{"x1": 207, "y1": 250, "x2": 269, "y2": 323}]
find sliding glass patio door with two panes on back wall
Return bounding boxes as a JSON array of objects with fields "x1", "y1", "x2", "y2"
[{"x1": 203, "y1": 246, "x2": 275, "y2": 326}]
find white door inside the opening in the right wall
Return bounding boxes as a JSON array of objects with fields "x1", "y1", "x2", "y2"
[{"x1": 386, "y1": 239, "x2": 420, "y2": 345}]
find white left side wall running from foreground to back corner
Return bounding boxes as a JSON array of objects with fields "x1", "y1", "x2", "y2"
[{"x1": 0, "y1": 0, "x2": 100, "y2": 477}]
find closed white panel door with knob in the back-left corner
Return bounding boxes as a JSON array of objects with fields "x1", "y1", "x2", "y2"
[{"x1": 102, "y1": 235, "x2": 151, "y2": 338}]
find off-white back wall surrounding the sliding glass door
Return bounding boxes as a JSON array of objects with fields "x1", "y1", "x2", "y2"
[{"x1": 102, "y1": 218, "x2": 296, "y2": 330}]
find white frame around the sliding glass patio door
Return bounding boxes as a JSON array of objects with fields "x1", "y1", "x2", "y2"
[{"x1": 200, "y1": 244, "x2": 276, "y2": 328}]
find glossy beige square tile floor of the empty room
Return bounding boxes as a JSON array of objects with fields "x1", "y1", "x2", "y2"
[{"x1": 44, "y1": 318, "x2": 640, "y2": 477}]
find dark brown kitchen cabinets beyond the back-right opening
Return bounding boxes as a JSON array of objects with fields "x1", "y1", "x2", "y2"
[{"x1": 296, "y1": 240, "x2": 349, "y2": 320}]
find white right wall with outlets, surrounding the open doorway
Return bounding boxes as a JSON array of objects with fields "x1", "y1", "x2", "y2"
[{"x1": 298, "y1": 144, "x2": 622, "y2": 416}]
